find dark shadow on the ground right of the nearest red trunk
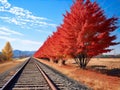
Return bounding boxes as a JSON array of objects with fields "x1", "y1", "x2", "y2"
[{"x1": 88, "y1": 65, "x2": 120, "y2": 77}]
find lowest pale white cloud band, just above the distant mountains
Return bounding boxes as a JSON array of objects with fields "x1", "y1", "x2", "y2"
[{"x1": 0, "y1": 36, "x2": 43, "y2": 50}]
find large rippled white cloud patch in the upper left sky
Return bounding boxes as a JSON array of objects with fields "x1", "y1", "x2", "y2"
[{"x1": 0, "y1": 0, "x2": 56, "y2": 28}]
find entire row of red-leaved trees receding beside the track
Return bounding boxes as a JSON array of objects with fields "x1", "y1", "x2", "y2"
[{"x1": 34, "y1": 0, "x2": 117, "y2": 68}]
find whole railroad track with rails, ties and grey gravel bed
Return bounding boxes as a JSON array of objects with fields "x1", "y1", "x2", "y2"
[{"x1": 0, "y1": 58, "x2": 88, "y2": 90}]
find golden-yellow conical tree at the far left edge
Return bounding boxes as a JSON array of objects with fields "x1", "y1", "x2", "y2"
[{"x1": 0, "y1": 42, "x2": 13, "y2": 62}]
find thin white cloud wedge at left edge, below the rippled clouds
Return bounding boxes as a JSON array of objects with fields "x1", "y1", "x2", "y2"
[{"x1": 0, "y1": 27, "x2": 23, "y2": 35}]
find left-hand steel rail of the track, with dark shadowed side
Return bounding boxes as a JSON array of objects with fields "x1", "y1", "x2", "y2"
[{"x1": 0, "y1": 58, "x2": 30, "y2": 90}]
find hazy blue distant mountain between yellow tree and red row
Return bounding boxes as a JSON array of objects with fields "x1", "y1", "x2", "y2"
[{"x1": 13, "y1": 50, "x2": 35, "y2": 58}]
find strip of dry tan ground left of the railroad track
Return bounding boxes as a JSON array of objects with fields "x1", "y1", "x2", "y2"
[{"x1": 0, "y1": 59, "x2": 26, "y2": 73}]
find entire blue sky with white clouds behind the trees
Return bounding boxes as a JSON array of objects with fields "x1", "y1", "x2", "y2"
[{"x1": 0, "y1": 0, "x2": 120, "y2": 54}]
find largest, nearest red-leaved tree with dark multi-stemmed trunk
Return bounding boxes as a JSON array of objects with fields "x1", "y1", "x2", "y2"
[{"x1": 56, "y1": 0, "x2": 117, "y2": 68}]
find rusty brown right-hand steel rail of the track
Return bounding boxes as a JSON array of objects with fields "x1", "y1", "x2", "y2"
[{"x1": 35, "y1": 62, "x2": 58, "y2": 90}]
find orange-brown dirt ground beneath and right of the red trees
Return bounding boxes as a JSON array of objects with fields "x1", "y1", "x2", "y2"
[{"x1": 36, "y1": 58, "x2": 120, "y2": 90}]
